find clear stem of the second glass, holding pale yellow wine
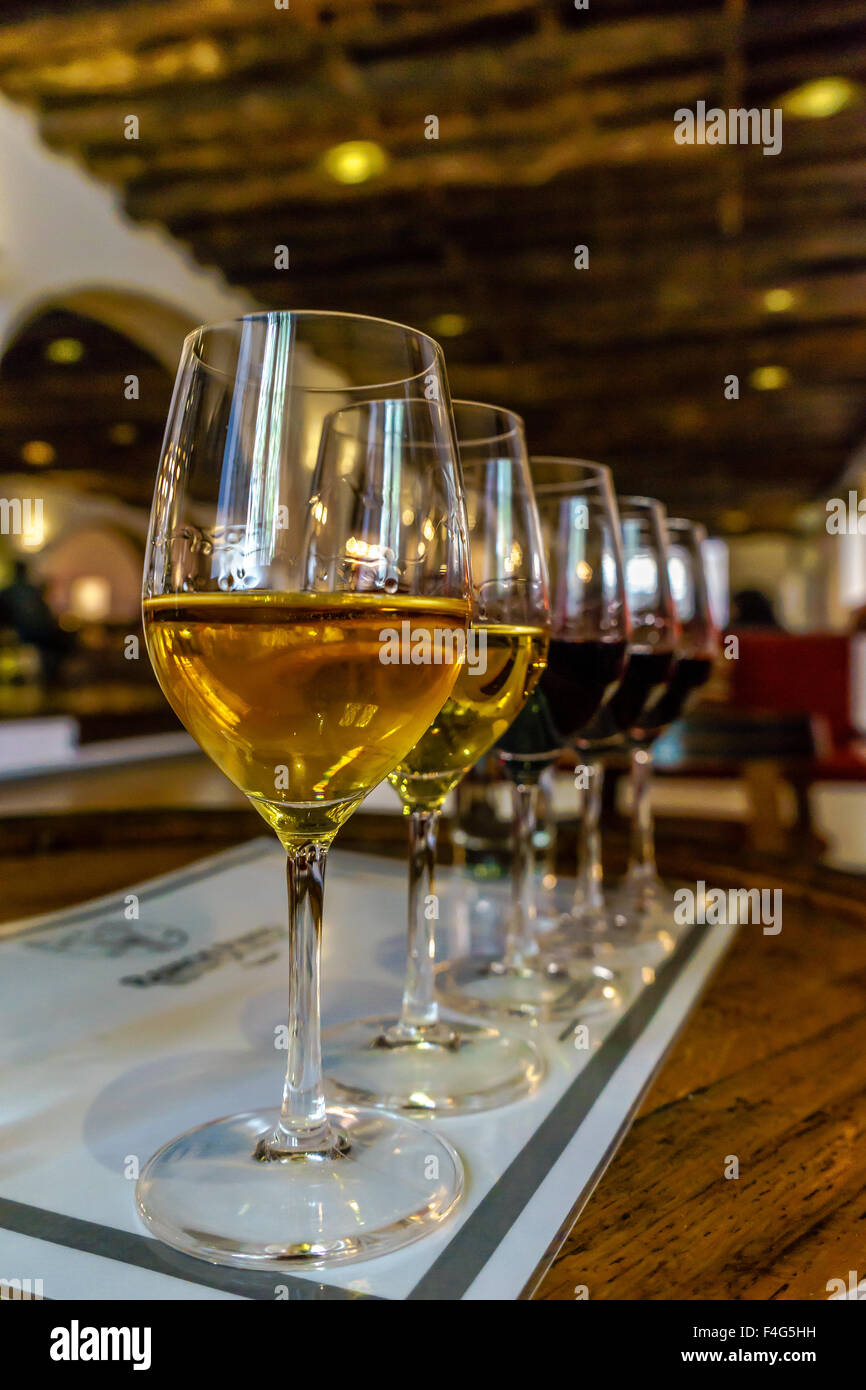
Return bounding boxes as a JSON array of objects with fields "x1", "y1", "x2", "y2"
[{"x1": 400, "y1": 806, "x2": 439, "y2": 1033}]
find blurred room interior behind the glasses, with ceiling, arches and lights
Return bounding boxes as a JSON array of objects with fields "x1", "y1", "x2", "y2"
[{"x1": 0, "y1": 0, "x2": 866, "y2": 867}]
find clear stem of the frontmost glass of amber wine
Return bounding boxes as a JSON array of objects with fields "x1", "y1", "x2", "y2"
[{"x1": 256, "y1": 845, "x2": 338, "y2": 1158}]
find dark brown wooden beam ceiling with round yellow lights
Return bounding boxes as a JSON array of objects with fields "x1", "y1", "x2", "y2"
[{"x1": 0, "y1": 0, "x2": 866, "y2": 524}]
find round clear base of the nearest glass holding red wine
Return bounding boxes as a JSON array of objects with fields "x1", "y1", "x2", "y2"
[{"x1": 436, "y1": 955, "x2": 623, "y2": 1023}]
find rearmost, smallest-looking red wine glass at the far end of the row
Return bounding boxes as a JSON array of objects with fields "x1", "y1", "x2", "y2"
[{"x1": 617, "y1": 517, "x2": 719, "y2": 930}]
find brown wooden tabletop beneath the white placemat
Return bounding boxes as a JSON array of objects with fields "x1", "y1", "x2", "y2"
[{"x1": 0, "y1": 810, "x2": 866, "y2": 1300}]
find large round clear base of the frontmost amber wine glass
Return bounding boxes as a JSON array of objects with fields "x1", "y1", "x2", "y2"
[{"x1": 135, "y1": 1106, "x2": 463, "y2": 1270}]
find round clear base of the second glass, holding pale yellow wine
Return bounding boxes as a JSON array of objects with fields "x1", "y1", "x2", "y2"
[{"x1": 322, "y1": 1019, "x2": 545, "y2": 1115}]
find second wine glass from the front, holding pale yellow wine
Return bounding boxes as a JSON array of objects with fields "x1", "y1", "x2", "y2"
[{"x1": 324, "y1": 400, "x2": 549, "y2": 1115}]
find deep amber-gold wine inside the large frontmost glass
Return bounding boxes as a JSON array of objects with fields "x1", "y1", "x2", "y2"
[{"x1": 145, "y1": 591, "x2": 468, "y2": 848}]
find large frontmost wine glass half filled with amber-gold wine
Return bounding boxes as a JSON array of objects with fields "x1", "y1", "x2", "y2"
[{"x1": 136, "y1": 311, "x2": 470, "y2": 1269}]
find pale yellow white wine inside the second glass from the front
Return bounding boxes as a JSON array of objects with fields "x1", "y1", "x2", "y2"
[{"x1": 389, "y1": 623, "x2": 548, "y2": 810}]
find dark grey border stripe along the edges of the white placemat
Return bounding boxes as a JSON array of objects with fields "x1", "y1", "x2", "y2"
[{"x1": 0, "y1": 840, "x2": 703, "y2": 1301}]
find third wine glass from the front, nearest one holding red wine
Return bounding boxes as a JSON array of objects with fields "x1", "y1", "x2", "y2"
[{"x1": 438, "y1": 457, "x2": 630, "y2": 1022}]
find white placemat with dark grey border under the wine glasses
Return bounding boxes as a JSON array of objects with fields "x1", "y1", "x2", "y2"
[{"x1": 0, "y1": 840, "x2": 735, "y2": 1300}]
